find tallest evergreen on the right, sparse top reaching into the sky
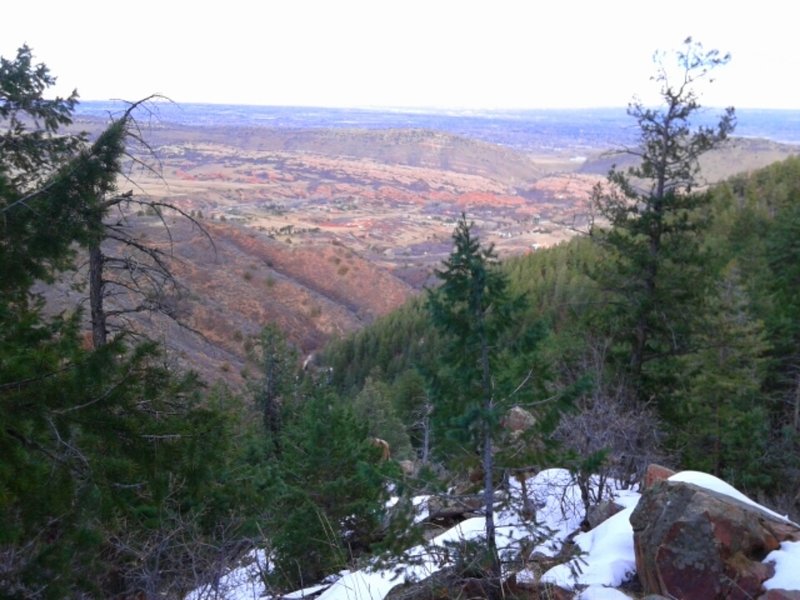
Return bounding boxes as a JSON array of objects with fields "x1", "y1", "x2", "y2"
[{"x1": 592, "y1": 38, "x2": 735, "y2": 398}]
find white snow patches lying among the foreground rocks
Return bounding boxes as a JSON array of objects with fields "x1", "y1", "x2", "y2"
[{"x1": 188, "y1": 469, "x2": 800, "y2": 600}]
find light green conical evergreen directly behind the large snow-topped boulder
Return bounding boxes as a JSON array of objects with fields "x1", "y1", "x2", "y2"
[{"x1": 675, "y1": 263, "x2": 769, "y2": 489}]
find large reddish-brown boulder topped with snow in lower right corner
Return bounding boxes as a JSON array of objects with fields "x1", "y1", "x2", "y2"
[{"x1": 630, "y1": 481, "x2": 800, "y2": 600}]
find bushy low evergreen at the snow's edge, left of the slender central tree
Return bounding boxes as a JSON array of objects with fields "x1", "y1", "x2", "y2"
[{"x1": 267, "y1": 388, "x2": 387, "y2": 589}]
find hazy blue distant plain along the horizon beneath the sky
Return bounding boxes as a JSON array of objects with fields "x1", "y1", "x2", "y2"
[{"x1": 70, "y1": 100, "x2": 800, "y2": 151}]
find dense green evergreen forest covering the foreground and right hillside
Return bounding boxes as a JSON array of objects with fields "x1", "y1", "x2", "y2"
[{"x1": 0, "y1": 43, "x2": 800, "y2": 598}]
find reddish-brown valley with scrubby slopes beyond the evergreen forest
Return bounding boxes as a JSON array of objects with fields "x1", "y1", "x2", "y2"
[{"x1": 62, "y1": 105, "x2": 796, "y2": 385}]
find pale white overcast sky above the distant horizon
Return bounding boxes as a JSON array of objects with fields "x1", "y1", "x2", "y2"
[{"x1": 0, "y1": 0, "x2": 800, "y2": 109}]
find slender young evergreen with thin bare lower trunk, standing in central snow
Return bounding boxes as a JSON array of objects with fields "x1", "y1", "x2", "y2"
[{"x1": 427, "y1": 214, "x2": 538, "y2": 577}]
